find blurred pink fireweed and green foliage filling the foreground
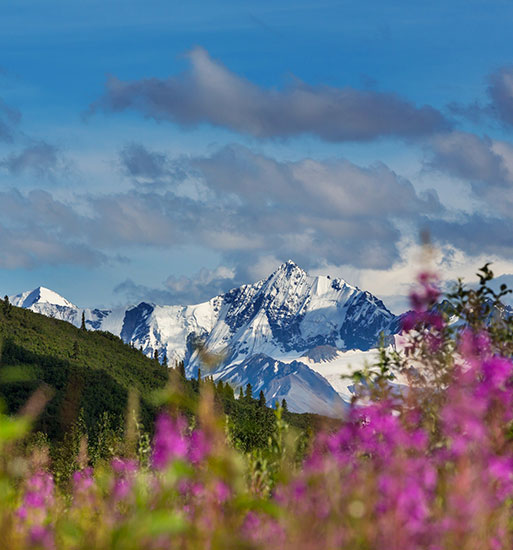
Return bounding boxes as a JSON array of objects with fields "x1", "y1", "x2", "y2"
[{"x1": 0, "y1": 273, "x2": 513, "y2": 550}]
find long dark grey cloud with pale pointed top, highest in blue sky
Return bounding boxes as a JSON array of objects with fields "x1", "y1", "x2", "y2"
[{"x1": 91, "y1": 48, "x2": 450, "y2": 142}]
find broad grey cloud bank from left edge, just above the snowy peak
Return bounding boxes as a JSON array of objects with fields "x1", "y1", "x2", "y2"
[{"x1": 0, "y1": 146, "x2": 444, "y2": 276}]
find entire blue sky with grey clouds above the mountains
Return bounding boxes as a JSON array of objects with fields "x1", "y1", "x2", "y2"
[{"x1": 0, "y1": 0, "x2": 513, "y2": 312}]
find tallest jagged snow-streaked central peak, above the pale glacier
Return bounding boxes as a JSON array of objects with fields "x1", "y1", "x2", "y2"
[{"x1": 190, "y1": 261, "x2": 397, "y2": 367}]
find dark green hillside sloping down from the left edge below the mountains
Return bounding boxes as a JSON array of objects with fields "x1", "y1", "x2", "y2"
[{"x1": 0, "y1": 302, "x2": 168, "y2": 439}]
